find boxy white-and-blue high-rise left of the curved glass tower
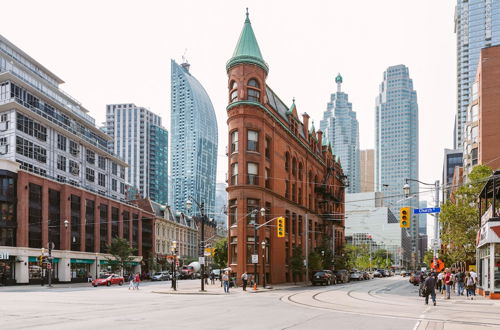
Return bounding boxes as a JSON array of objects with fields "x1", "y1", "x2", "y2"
[{"x1": 106, "y1": 103, "x2": 168, "y2": 204}]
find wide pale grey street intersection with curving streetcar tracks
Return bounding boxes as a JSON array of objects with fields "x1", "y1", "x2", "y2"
[{"x1": 0, "y1": 277, "x2": 500, "y2": 330}]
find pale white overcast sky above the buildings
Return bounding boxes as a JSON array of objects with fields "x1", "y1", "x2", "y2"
[{"x1": 0, "y1": 0, "x2": 456, "y2": 229}]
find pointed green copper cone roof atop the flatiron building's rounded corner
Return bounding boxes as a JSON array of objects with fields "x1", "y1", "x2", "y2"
[{"x1": 226, "y1": 8, "x2": 269, "y2": 73}]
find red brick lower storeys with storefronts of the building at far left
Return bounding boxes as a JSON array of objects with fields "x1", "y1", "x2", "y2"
[{"x1": 0, "y1": 159, "x2": 155, "y2": 284}]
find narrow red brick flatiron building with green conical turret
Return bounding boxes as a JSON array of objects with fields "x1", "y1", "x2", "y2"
[{"x1": 226, "y1": 14, "x2": 345, "y2": 283}]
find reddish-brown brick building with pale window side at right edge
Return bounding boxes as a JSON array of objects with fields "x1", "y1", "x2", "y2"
[{"x1": 463, "y1": 46, "x2": 500, "y2": 175}]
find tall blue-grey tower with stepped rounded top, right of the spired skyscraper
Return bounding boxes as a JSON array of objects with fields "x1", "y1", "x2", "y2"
[{"x1": 375, "y1": 65, "x2": 419, "y2": 260}]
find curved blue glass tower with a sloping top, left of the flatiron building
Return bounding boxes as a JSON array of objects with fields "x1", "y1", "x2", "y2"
[{"x1": 170, "y1": 60, "x2": 218, "y2": 215}]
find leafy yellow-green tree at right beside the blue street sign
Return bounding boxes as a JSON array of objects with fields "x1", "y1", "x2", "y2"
[{"x1": 439, "y1": 165, "x2": 492, "y2": 263}]
